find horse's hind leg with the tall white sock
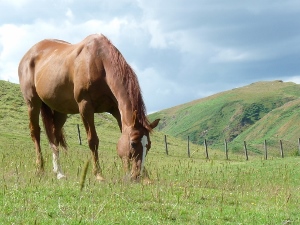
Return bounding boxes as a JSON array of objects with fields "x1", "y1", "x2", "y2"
[{"x1": 50, "y1": 111, "x2": 67, "y2": 179}]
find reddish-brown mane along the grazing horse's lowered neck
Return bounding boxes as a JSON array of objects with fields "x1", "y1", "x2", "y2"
[{"x1": 106, "y1": 38, "x2": 152, "y2": 132}]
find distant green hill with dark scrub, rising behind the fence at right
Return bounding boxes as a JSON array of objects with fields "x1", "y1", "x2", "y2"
[{"x1": 150, "y1": 81, "x2": 300, "y2": 152}]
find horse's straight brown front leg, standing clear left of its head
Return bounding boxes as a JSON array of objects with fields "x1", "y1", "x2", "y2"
[{"x1": 79, "y1": 100, "x2": 104, "y2": 181}]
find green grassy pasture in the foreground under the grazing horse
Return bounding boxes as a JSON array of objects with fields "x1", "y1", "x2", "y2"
[{"x1": 0, "y1": 114, "x2": 300, "y2": 224}]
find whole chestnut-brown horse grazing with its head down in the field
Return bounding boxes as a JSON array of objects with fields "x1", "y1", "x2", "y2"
[{"x1": 19, "y1": 34, "x2": 159, "y2": 180}]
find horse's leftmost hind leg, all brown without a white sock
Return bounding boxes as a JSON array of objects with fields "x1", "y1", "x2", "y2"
[{"x1": 27, "y1": 98, "x2": 44, "y2": 173}]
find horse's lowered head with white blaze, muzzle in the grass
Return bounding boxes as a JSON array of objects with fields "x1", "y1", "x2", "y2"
[{"x1": 117, "y1": 112, "x2": 159, "y2": 180}]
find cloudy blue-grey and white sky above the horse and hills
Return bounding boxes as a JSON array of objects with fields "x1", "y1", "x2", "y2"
[{"x1": 0, "y1": 0, "x2": 300, "y2": 112}]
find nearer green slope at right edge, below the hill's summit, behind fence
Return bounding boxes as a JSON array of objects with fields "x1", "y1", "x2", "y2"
[{"x1": 232, "y1": 99, "x2": 300, "y2": 154}]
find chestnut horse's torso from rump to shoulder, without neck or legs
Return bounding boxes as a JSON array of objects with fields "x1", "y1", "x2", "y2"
[{"x1": 19, "y1": 35, "x2": 115, "y2": 113}]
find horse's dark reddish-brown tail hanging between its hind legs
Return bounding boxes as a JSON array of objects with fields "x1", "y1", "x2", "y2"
[{"x1": 41, "y1": 102, "x2": 67, "y2": 149}]
